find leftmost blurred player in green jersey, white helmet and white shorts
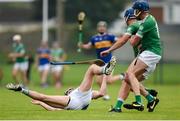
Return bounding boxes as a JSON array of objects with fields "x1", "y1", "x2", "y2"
[{"x1": 9, "y1": 34, "x2": 29, "y2": 85}]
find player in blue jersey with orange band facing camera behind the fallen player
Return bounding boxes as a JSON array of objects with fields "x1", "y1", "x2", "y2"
[{"x1": 78, "y1": 21, "x2": 120, "y2": 100}]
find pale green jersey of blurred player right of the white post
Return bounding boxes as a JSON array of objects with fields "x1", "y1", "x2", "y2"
[{"x1": 51, "y1": 48, "x2": 64, "y2": 61}]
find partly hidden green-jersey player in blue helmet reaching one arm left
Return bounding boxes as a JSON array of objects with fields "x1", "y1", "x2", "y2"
[{"x1": 101, "y1": 6, "x2": 160, "y2": 112}]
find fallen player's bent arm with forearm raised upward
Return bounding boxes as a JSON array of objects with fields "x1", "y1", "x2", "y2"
[{"x1": 92, "y1": 75, "x2": 107, "y2": 99}]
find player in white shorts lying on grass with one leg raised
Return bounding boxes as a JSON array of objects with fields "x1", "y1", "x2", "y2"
[{"x1": 7, "y1": 57, "x2": 116, "y2": 111}]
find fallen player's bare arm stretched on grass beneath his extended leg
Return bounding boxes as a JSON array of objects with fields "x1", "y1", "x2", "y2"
[{"x1": 32, "y1": 100, "x2": 63, "y2": 111}]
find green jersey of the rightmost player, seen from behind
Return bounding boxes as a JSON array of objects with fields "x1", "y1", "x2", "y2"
[{"x1": 136, "y1": 15, "x2": 162, "y2": 55}]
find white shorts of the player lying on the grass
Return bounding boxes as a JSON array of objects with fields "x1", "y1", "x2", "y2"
[{"x1": 65, "y1": 88, "x2": 92, "y2": 110}]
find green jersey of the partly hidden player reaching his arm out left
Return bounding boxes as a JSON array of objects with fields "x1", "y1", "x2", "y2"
[{"x1": 126, "y1": 21, "x2": 141, "y2": 57}]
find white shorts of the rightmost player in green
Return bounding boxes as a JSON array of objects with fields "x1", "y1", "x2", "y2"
[{"x1": 138, "y1": 51, "x2": 161, "y2": 79}]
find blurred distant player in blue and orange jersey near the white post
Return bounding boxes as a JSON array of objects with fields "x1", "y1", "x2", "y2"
[{"x1": 36, "y1": 42, "x2": 50, "y2": 87}]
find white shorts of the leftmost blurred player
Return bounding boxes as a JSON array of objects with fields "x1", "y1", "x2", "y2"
[{"x1": 13, "y1": 62, "x2": 28, "y2": 71}]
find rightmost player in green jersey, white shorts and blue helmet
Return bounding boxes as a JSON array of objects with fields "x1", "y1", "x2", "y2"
[{"x1": 123, "y1": 1, "x2": 162, "y2": 112}]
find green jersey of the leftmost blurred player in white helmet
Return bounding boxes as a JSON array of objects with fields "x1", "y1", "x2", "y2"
[{"x1": 13, "y1": 43, "x2": 26, "y2": 63}]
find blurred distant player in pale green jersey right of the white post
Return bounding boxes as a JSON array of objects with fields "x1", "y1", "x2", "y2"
[{"x1": 51, "y1": 42, "x2": 66, "y2": 88}]
